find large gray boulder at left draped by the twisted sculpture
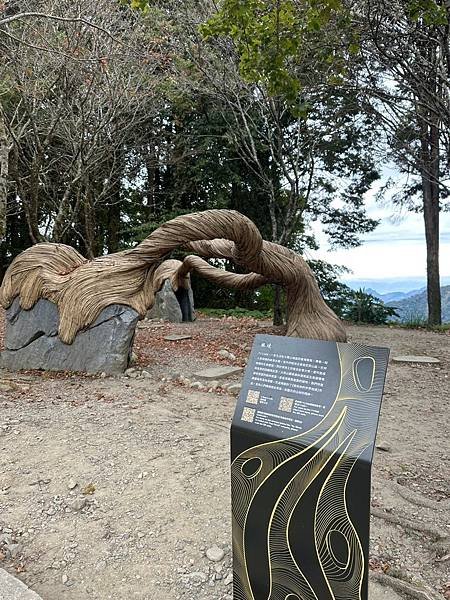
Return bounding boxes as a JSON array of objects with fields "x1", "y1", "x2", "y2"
[{"x1": 1, "y1": 298, "x2": 139, "y2": 374}]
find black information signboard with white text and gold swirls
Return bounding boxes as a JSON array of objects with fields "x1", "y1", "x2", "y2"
[{"x1": 231, "y1": 335, "x2": 389, "y2": 600}]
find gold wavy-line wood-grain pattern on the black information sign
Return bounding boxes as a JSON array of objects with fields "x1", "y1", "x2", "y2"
[{"x1": 232, "y1": 343, "x2": 386, "y2": 600}]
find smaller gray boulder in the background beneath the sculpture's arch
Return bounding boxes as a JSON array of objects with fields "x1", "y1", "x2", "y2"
[{"x1": 147, "y1": 279, "x2": 195, "y2": 323}]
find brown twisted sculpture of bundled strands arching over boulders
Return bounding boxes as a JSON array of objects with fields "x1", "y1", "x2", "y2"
[{"x1": 0, "y1": 210, "x2": 346, "y2": 344}]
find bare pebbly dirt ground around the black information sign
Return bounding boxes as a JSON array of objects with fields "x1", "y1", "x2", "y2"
[{"x1": 0, "y1": 320, "x2": 450, "y2": 600}]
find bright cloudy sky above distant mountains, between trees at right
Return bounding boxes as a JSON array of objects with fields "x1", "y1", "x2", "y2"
[{"x1": 310, "y1": 176, "x2": 450, "y2": 288}]
